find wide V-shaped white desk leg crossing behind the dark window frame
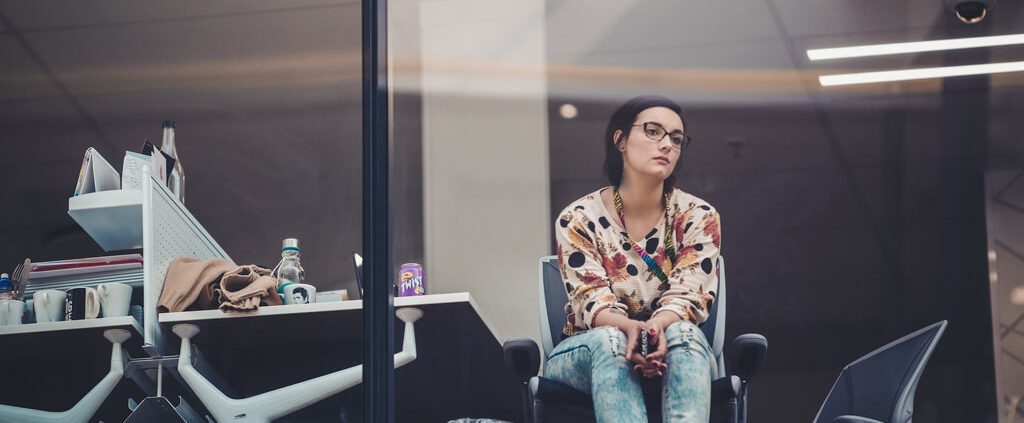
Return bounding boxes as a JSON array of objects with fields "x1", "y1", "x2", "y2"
[{"x1": 173, "y1": 307, "x2": 423, "y2": 423}]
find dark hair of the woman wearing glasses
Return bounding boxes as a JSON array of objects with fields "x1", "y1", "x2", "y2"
[{"x1": 603, "y1": 95, "x2": 686, "y2": 192}]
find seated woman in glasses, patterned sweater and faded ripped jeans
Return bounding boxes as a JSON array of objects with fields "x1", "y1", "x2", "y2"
[{"x1": 545, "y1": 96, "x2": 721, "y2": 422}]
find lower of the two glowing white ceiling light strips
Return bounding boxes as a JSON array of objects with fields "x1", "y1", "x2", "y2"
[{"x1": 818, "y1": 61, "x2": 1024, "y2": 87}]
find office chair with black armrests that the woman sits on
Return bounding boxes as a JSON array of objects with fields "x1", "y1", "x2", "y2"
[{"x1": 504, "y1": 256, "x2": 768, "y2": 423}]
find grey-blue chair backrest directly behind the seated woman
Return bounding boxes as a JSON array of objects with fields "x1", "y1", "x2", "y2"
[{"x1": 538, "y1": 256, "x2": 725, "y2": 377}]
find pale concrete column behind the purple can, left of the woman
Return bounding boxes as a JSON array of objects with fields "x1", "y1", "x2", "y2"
[{"x1": 417, "y1": 0, "x2": 552, "y2": 340}]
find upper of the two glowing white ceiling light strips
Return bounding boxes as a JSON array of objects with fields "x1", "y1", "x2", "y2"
[{"x1": 807, "y1": 34, "x2": 1024, "y2": 61}]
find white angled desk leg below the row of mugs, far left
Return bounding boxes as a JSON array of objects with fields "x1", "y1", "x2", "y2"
[{"x1": 0, "y1": 329, "x2": 131, "y2": 423}]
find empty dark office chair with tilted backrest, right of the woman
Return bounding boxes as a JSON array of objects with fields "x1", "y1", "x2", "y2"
[{"x1": 814, "y1": 321, "x2": 947, "y2": 423}]
